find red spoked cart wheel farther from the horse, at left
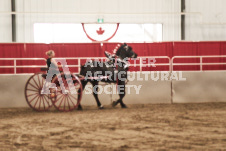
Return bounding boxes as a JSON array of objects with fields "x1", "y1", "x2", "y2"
[{"x1": 25, "y1": 73, "x2": 52, "y2": 111}]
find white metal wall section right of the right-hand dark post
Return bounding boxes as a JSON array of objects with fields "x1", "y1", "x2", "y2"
[{"x1": 186, "y1": 0, "x2": 226, "y2": 41}]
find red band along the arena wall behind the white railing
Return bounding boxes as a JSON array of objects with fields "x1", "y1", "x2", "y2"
[{"x1": 0, "y1": 41, "x2": 226, "y2": 73}]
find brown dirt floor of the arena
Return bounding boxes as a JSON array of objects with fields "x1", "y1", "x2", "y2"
[{"x1": 0, "y1": 103, "x2": 226, "y2": 151}]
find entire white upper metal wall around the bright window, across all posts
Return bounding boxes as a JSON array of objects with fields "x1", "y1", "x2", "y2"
[{"x1": 0, "y1": 0, "x2": 226, "y2": 42}]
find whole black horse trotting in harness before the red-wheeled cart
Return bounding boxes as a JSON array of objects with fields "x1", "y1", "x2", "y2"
[{"x1": 78, "y1": 43, "x2": 137, "y2": 109}]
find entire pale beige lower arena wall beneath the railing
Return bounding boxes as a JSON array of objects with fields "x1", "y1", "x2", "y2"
[{"x1": 0, "y1": 71, "x2": 226, "y2": 108}]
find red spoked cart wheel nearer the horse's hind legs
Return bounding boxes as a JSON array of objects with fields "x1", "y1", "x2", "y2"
[{"x1": 52, "y1": 73, "x2": 82, "y2": 112}]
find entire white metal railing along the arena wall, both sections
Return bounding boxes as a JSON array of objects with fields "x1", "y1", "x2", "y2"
[{"x1": 0, "y1": 55, "x2": 226, "y2": 74}]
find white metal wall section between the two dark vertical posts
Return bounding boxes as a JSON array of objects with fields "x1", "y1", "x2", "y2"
[{"x1": 14, "y1": 0, "x2": 180, "y2": 42}]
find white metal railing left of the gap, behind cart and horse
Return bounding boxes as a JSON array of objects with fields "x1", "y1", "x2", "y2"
[{"x1": 0, "y1": 56, "x2": 171, "y2": 74}]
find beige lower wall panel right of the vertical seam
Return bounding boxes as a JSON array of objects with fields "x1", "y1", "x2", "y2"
[{"x1": 173, "y1": 71, "x2": 226, "y2": 103}]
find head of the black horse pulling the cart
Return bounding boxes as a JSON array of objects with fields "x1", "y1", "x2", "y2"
[{"x1": 116, "y1": 43, "x2": 137, "y2": 59}]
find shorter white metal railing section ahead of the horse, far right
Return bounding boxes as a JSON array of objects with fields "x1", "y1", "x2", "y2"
[{"x1": 171, "y1": 55, "x2": 226, "y2": 71}]
